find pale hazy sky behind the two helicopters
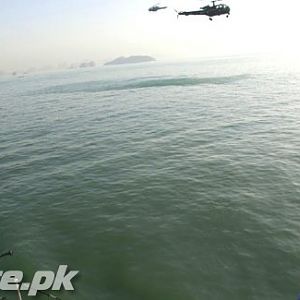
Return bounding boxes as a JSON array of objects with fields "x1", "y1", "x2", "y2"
[{"x1": 0, "y1": 0, "x2": 300, "y2": 71}]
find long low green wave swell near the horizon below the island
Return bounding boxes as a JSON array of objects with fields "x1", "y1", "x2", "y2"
[{"x1": 41, "y1": 74, "x2": 250, "y2": 94}]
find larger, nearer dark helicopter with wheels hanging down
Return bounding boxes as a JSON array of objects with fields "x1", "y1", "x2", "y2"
[{"x1": 177, "y1": 0, "x2": 230, "y2": 21}]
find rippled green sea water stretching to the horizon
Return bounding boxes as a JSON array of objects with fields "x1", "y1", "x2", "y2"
[{"x1": 0, "y1": 57, "x2": 300, "y2": 300}]
